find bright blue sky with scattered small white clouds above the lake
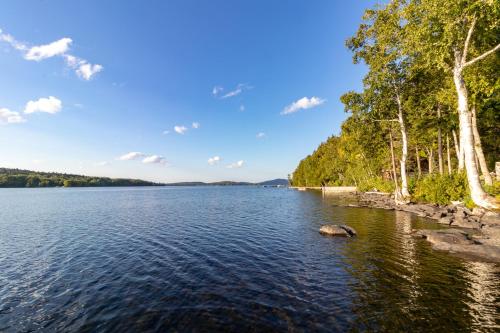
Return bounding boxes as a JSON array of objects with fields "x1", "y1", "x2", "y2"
[{"x1": 0, "y1": 0, "x2": 374, "y2": 182}]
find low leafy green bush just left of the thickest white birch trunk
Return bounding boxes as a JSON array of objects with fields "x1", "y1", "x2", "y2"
[{"x1": 411, "y1": 173, "x2": 469, "y2": 205}]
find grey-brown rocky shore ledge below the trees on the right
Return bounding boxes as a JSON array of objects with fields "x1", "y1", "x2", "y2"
[{"x1": 347, "y1": 192, "x2": 500, "y2": 263}]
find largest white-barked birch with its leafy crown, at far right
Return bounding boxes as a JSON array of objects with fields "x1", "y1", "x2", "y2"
[{"x1": 405, "y1": 0, "x2": 500, "y2": 208}]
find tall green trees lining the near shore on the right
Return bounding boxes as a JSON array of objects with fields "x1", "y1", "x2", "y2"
[{"x1": 292, "y1": 0, "x2": 500, "y2": 208}]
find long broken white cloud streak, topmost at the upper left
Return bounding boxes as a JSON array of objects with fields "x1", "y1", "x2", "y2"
[{"x1": 0, "y1": 29, "x2": 104, "y2": 81}]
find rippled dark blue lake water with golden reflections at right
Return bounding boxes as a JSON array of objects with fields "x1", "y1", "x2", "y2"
[{"x1": 0, "y1": 187, "x2": 500, "y2": 332}]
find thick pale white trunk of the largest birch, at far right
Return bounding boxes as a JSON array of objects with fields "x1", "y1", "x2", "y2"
[{"x1": 453, "y1": 57, "x2": 498, "y2": 208}]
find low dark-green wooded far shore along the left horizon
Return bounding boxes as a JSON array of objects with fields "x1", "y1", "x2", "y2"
[{"x1": 0, "y1": 168, "x2": 161, "y2": 187}]
